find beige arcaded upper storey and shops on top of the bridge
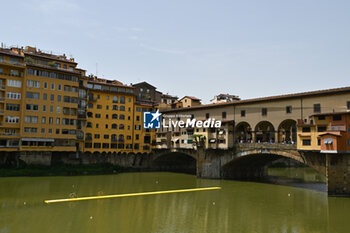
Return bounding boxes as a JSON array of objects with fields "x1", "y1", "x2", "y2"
[{"x1": 157, "y1": 87, "x2": 350, "y2": 149}]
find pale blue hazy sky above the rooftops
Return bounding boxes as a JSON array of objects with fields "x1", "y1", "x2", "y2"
[{"x1": 0, "y1": 0, "x2": 350, "y2": 103}]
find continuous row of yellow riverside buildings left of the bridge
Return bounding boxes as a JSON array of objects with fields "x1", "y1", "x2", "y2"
[{"x1": 0, "y1": 47, "x2": 155, "y2": 155}]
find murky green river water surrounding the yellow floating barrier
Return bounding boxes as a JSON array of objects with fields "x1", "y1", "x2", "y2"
[{"x1": 0, "y1": 170, "x2": 350, "y2": 233}]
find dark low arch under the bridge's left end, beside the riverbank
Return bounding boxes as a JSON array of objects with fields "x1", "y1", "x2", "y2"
[{"x1": 152, "y1": 151, "x2": 197, "y2": 174}]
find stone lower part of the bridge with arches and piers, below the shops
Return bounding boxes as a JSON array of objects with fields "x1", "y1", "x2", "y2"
[{"x1": 152, "y1": 143, "x2": 350, "y2": 195}]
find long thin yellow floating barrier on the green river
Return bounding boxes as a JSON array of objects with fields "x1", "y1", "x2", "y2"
[{"x1": 44, "y1": 187, "x2": 221, "y2": 204}]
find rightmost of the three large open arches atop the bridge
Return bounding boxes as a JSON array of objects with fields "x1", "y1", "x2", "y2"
[{"x1": 278, "y1": 119, "x2": 297, "y2": 144}]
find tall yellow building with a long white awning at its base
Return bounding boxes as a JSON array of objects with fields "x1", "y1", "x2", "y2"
[{"x1": 20, "y1": 47, "x2": 81, "y2": 151}]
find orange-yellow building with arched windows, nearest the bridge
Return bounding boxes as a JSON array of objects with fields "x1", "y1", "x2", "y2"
[{"x1": 84, "y1": 78, "x2": 155, "y2": 153}]
